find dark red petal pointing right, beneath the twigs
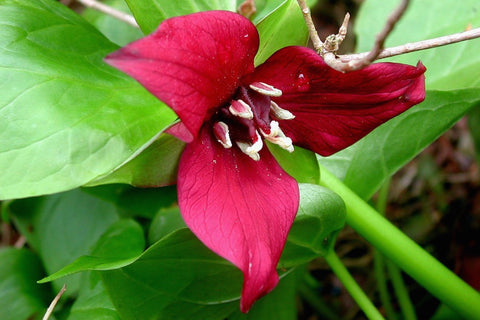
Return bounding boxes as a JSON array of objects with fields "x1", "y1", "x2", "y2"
[{"x1": 245, "y1": 47, "x2": 425, "y2": 156}]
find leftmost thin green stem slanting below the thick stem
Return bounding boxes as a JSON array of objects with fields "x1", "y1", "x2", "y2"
[{"x1": 324, "y1": 250, "x2": 384, "y2": 320}]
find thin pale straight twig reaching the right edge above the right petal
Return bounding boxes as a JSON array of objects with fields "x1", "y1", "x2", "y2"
[{"x1": 339, "y1": 28, "x2": 480, "y2": 63}]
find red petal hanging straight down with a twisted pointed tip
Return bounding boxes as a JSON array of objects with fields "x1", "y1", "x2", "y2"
[{"x1": 178, "y1": 129, "x2": 299, "y2": 312}]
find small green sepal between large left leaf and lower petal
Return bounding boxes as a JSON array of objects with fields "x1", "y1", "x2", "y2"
[{"x1": 91, "y1": 134, "x2": 185, "y2": 187}]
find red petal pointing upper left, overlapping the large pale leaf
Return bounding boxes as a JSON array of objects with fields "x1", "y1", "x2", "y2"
[{"x1": 105, "y1": 11, "x2": 258, "y2": 136}]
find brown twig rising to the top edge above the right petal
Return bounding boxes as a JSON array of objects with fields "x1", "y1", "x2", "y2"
[{"x1": 348, "y1": 0, "x2": 410, "y2": 70}]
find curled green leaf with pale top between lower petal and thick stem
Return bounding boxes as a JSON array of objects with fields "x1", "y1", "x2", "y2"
[{"x1": 279, "y1": 183, "x2": 346, "y2": 268}]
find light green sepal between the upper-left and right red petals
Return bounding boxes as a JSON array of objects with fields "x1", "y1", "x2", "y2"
[{"x1": 255, "y1": 0, "x2": 308, "y2": 65}]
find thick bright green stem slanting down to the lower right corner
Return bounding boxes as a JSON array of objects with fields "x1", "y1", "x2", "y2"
[{"x1": 321, "y1": 166, "x2": 480, "y2": 319}]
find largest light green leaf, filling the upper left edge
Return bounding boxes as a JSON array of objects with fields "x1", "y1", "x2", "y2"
[{"x1": 0, "y1": 0, "x2": 175, "y2": 199}]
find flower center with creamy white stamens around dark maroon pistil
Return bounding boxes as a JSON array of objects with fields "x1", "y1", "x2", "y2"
[{"x1": 212, "y1": 82, "x2": 295, "y2": 161}]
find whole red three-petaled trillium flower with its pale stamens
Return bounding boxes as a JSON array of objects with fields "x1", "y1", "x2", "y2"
[{"x1": 106, "y1": 11, "x2": 425, "y2": 312}]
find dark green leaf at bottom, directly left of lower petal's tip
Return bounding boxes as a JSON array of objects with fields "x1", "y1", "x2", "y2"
[{"x1": 100, "y1": 229, "x2": 242, "y2": 319}]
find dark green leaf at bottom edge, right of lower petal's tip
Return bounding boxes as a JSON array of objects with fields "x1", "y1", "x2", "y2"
[{"x1": 228, "y1": 272, "x2": 297, "y2": 320}]
